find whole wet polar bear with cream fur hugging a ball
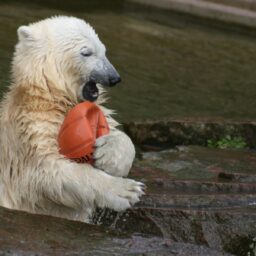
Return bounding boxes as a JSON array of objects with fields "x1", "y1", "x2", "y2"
[{"x1": 0, "y1": 16, "x2": 144, "y2": 222}]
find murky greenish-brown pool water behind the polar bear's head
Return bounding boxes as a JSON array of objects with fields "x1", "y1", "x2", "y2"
[{"x1": 0, "y1": 0, "x2": 256, "y2": 122}]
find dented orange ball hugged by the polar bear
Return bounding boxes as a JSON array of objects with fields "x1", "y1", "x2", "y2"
[{"x1": 58, "y1": 101, "x2": 109, "y2": 164}]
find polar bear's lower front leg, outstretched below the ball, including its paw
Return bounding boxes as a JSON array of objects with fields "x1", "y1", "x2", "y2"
[{"x1": 30, "y1": 157, "x2": 144, "y2": 221}]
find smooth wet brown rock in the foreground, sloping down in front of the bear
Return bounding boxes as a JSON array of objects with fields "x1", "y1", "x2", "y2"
[{"x1": 0, "y1": 208, "x2": 232, "y2": 256}]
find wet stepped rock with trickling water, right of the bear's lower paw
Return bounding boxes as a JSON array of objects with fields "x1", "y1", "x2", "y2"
[{"x1": 94, "y1": 146, "x2": 256, "y2": 256}]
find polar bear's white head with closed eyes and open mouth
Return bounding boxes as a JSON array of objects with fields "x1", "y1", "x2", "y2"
[{"x1": 12, "y1": 16, "x2": 120, "y2": 101}]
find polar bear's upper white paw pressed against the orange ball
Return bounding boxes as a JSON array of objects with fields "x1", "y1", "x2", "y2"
[{"x1": 93, "y1": 130, "x2": 135, "y2": 177}]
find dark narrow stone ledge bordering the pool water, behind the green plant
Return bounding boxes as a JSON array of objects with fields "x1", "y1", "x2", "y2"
[{"x1": 124, "y1": 119, "x2": 256, "y2": 150}]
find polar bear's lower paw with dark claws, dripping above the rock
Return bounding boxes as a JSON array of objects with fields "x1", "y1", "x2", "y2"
[{"x1": 97, "y1": 176, "x2": 144, "y2": 211}]
